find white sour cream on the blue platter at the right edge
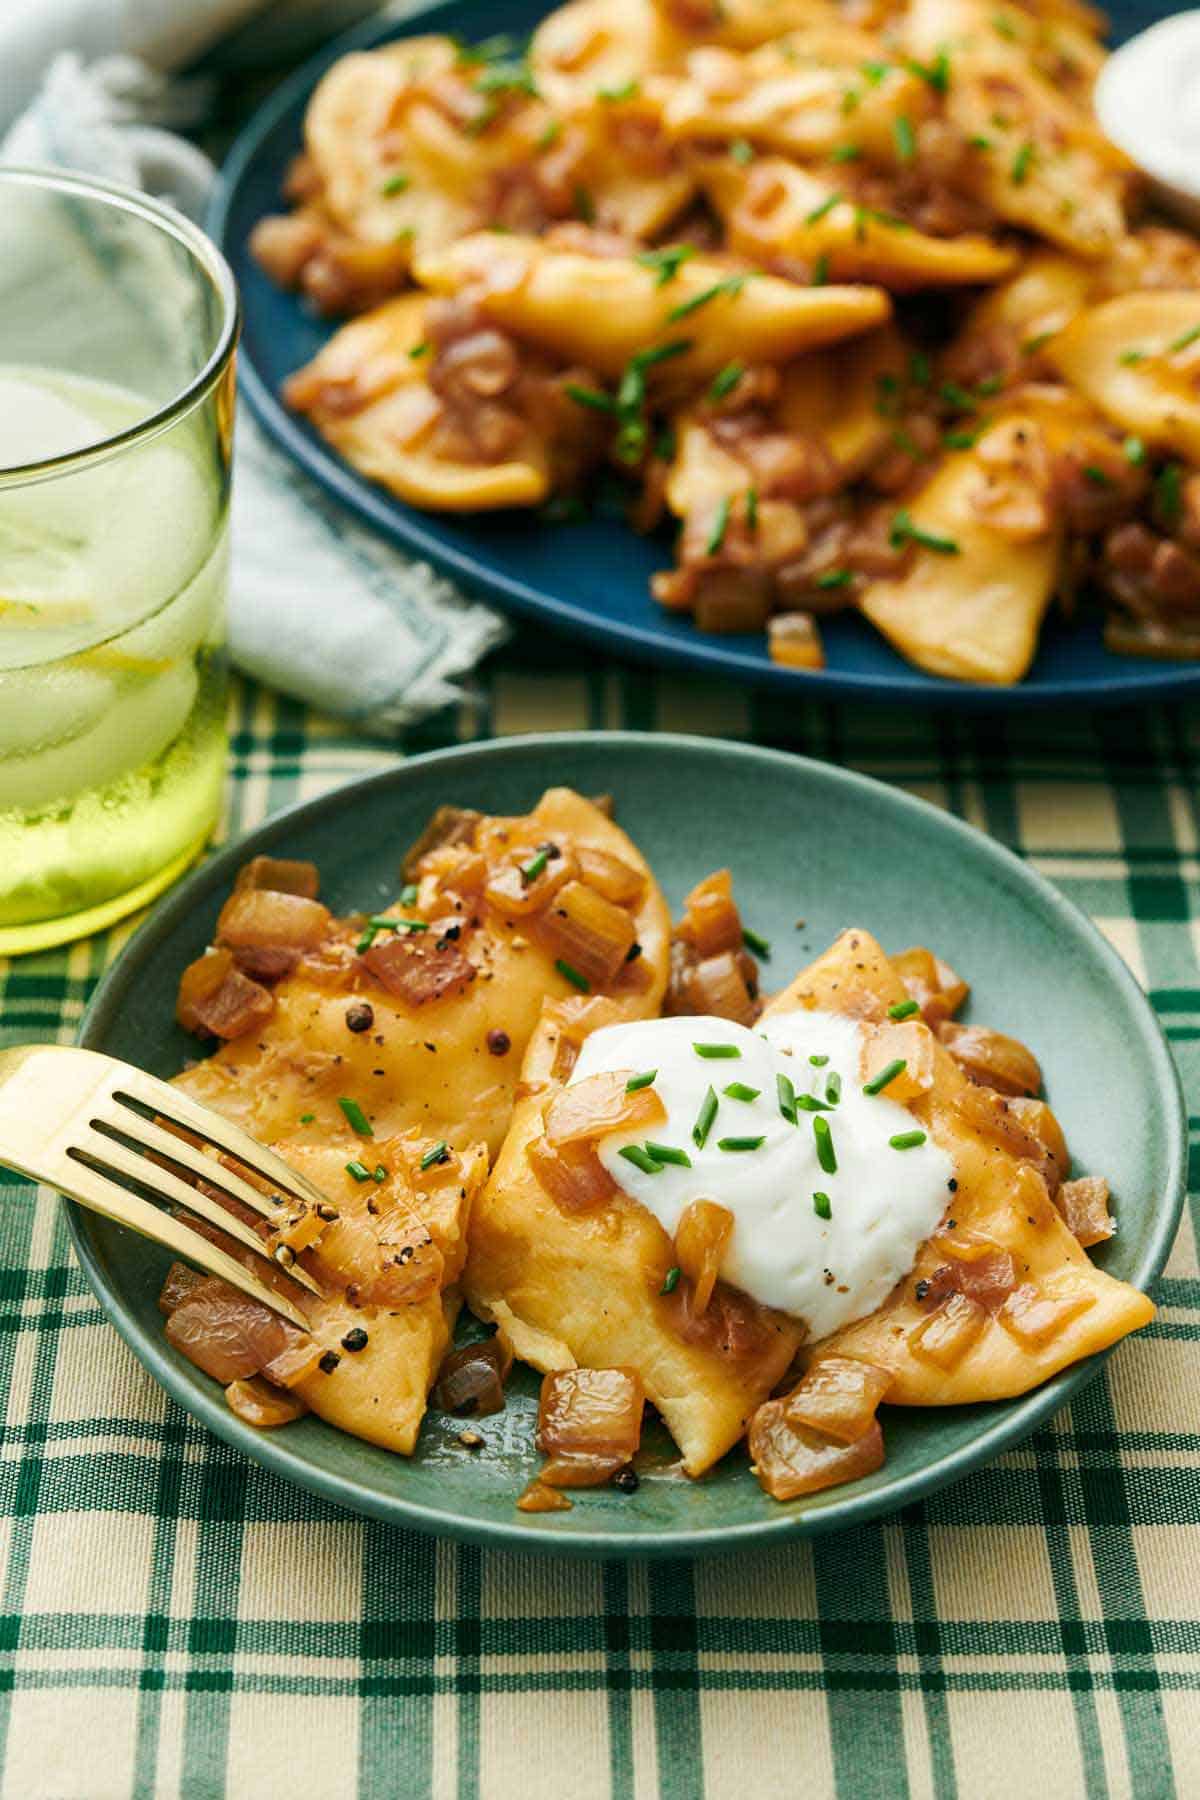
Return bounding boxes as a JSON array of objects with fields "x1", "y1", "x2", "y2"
[{"x1": 1094, "y1": 11, "x2": 1200, "y2": 220}]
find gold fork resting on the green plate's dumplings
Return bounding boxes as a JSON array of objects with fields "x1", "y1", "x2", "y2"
[{"x1": 0, "y1": 1044, "x2": 336, "y2": 1327}]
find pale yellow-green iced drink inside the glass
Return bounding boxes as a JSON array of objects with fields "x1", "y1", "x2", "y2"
[{"x1": 0, "y1": 367, "x2": 228, "y2": 950}]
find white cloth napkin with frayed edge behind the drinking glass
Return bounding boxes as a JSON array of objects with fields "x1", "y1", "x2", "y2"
[{"x1": 0, "y1": 0, "x2": 506, "y2": 734}]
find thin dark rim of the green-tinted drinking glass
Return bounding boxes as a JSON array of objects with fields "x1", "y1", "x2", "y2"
[{"x1": 0, "y1": 164, "x2": 241, "y2": 488}]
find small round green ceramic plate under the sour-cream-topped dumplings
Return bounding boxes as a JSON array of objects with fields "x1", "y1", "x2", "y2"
[{"x1": 70, "y1": 733, "x2": 1186, "y2": 1555}]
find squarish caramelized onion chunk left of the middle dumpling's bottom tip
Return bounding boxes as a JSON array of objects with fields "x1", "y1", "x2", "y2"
[{"x1": 538, "y1": 1368, "x2": 646, "y2": 1487}]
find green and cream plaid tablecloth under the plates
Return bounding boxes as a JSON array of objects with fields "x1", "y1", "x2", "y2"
[{"x1": 0, "y1": 643, "x2": 1200, "y2": 1800}]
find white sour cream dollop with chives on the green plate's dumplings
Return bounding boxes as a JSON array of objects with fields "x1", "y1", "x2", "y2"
[{"x1": 570, "y1": 1012, "x2": 954, "y2": 1339}]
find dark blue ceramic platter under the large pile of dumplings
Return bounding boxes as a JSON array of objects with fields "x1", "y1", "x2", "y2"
[{"x1": 210, "y1": 0, "x2": 1200, "y2": 709}]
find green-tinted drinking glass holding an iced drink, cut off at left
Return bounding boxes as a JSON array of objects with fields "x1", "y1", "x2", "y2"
[{"x1": 0, "y1": 169, "x2": 237, "y2": 954}]
